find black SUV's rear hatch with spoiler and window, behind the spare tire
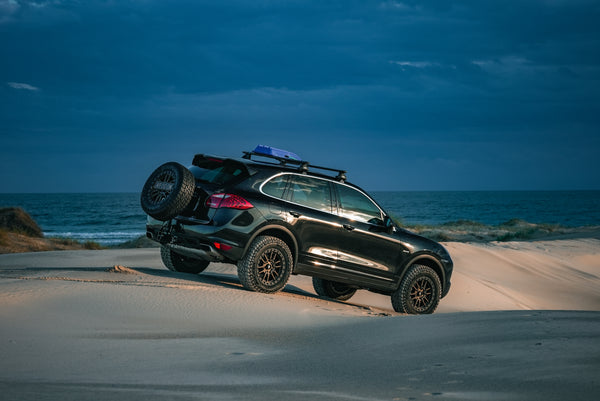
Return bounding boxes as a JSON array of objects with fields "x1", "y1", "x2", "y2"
[{"x1": 177, "y1": 154, "x2": 251, "y2": 224}]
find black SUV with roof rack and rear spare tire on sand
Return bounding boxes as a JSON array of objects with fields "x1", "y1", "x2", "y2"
[{"x1": 141, "y1": 146, "x2": 453, "y2": 314}]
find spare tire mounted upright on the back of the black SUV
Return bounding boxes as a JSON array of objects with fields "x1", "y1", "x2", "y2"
[{"x1": 140, "y1": 162, "x2": 196, "y2": 221}]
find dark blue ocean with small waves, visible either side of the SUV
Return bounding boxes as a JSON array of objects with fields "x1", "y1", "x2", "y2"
[{"x1": 0, "y1": 191, "x2": 600, "y2": 246}]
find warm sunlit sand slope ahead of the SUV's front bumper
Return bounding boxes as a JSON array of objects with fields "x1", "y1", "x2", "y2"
[{"x1": 440, "y1": 239, "x2": 600, "y2": 311}]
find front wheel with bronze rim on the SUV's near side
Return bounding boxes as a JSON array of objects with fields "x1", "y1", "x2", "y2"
[{"x1": 392, "y1": 265, "x2": 442, "y2": 315}]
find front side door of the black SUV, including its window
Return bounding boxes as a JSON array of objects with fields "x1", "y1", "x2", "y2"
[{"x1": 333, "y1": 183, "x2": 408, "y2": 282}]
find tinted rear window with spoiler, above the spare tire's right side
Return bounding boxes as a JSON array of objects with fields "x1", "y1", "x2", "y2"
[{"x1": 190, "y1": 157, "x2": 248, "y2": 186}]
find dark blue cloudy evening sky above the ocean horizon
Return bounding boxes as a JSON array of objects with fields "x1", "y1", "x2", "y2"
[{"x1": 0, "y1": 0, "x2": 600, "y2": 193}]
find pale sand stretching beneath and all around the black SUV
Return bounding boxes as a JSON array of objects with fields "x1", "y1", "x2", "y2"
[{"x1": 0, "y1": 238, "x2": 600, "y2": 401}]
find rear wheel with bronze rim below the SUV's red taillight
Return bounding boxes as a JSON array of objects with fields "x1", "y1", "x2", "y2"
[{"x1": 237, "y1": 235, "x2": 294, "y2": 293}]
